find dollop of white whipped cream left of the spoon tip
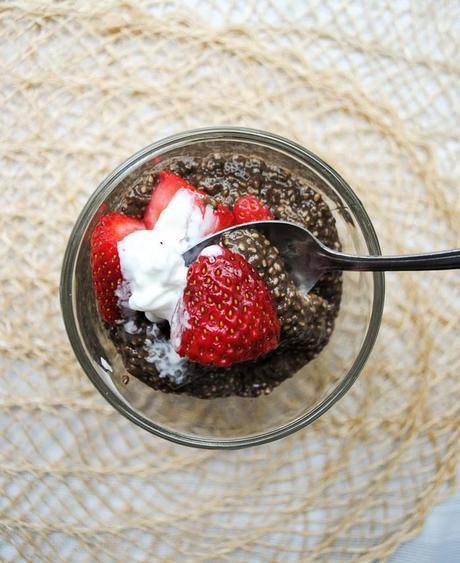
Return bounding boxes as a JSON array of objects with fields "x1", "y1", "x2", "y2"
[{"x1": 118, "y1": 189, "x2": 216, "y2": 322}]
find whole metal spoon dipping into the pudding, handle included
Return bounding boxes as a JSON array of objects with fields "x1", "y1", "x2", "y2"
[{"x1": 183, "y1": 221, "x2": 460, "y2": 292}]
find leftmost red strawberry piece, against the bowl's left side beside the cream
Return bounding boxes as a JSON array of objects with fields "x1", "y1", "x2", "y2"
[{"x1": 90, "y1": 213, "x2": 145, "y2": 324}]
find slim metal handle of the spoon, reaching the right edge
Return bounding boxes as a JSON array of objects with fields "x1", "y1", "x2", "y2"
[{"x1": 323, "y1": 249, "x2": 460, "y2": 272}]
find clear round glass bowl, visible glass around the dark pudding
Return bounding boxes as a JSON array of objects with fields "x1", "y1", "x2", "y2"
[{"x1": 61, "y1": 127, "x2": 384, "y2": 449}]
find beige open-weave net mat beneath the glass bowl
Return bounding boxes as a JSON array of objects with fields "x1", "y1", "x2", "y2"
[{"x1": 0, "y1": 0, "x2": 460, "y2": 562}]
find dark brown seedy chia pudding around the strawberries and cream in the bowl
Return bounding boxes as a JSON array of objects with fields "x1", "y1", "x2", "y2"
[{"x1": 101, "y1": 154, "x2": 342, "y2": 399}]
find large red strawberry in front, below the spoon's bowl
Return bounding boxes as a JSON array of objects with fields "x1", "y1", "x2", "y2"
[{"x1": 171, "y1": 249, "x2": 280, "y2": 367}]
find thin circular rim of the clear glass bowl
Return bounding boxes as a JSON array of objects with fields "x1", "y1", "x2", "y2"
[{"x1": 60, "y1": 126, "x2": 385, "y2": 449}]
